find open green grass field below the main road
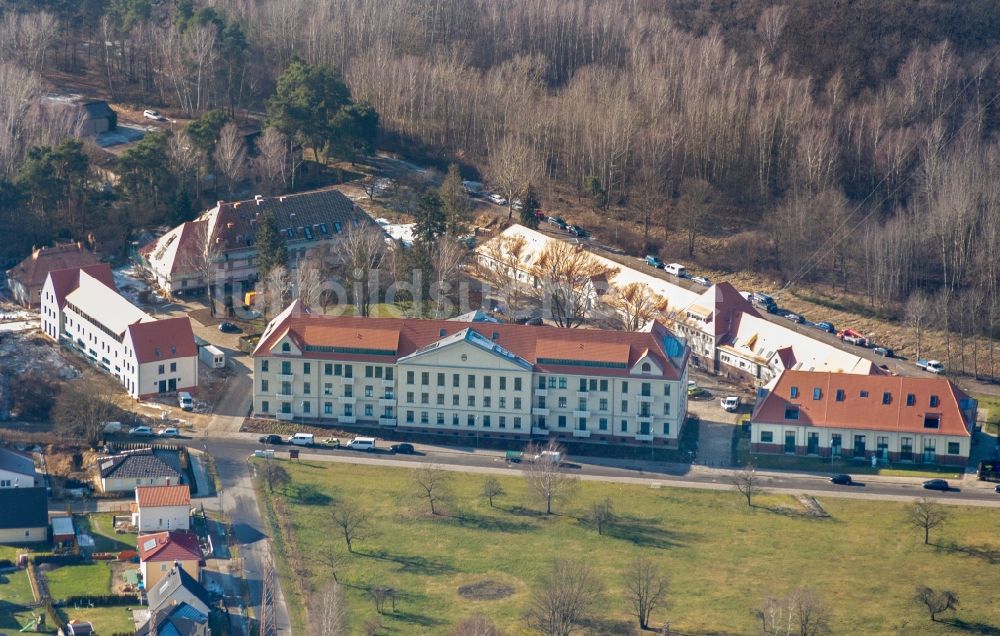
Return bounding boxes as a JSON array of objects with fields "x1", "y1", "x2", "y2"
[{"x1": 258, "y1": 462, "x2": 1000, "y2": 634}]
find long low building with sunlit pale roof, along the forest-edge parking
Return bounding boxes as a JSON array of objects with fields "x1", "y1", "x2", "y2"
[{"x1": 476, "y1": 225, "x2": 882, "y2": 386}]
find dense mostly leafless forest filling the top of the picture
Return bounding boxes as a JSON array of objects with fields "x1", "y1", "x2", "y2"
[{"x1": 0, "y1": 0, "x2": 1000, "y2": 352}]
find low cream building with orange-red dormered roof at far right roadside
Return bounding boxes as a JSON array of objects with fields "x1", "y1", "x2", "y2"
[{"x1": 750, "y1": 371, "x2": 977, "y2": 466}]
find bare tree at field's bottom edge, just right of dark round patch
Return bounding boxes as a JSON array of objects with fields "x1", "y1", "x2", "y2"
[{"x1": 526, "y1": 559, "x2": 603, "y2": 636}]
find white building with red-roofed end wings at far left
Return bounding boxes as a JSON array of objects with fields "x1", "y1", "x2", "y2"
[{"x1": 41, "y1": 265, "x2": 198, "y2": 398}]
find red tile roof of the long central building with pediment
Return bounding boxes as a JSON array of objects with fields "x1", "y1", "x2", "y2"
[{"x1": 254, "y1": 302, "x2": 688, "y2": 379}]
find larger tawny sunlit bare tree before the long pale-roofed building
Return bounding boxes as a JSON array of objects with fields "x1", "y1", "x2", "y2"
[{"x1": 532, "y1": 241, "x2": 618, "y2": 327}]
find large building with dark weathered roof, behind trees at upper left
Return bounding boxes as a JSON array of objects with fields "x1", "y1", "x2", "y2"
[{"x1": 140, "y1": 188, "x2": 377, "y2": 303}]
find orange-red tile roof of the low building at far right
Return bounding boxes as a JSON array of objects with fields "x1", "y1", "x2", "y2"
[{"x1": 752, "y1": 371, "x2": 975, "y2": 437}]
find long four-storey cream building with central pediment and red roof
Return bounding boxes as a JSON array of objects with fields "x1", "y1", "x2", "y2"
[{"x1": 253, "y1": 302, "x2": 689, "y2": 447}]
